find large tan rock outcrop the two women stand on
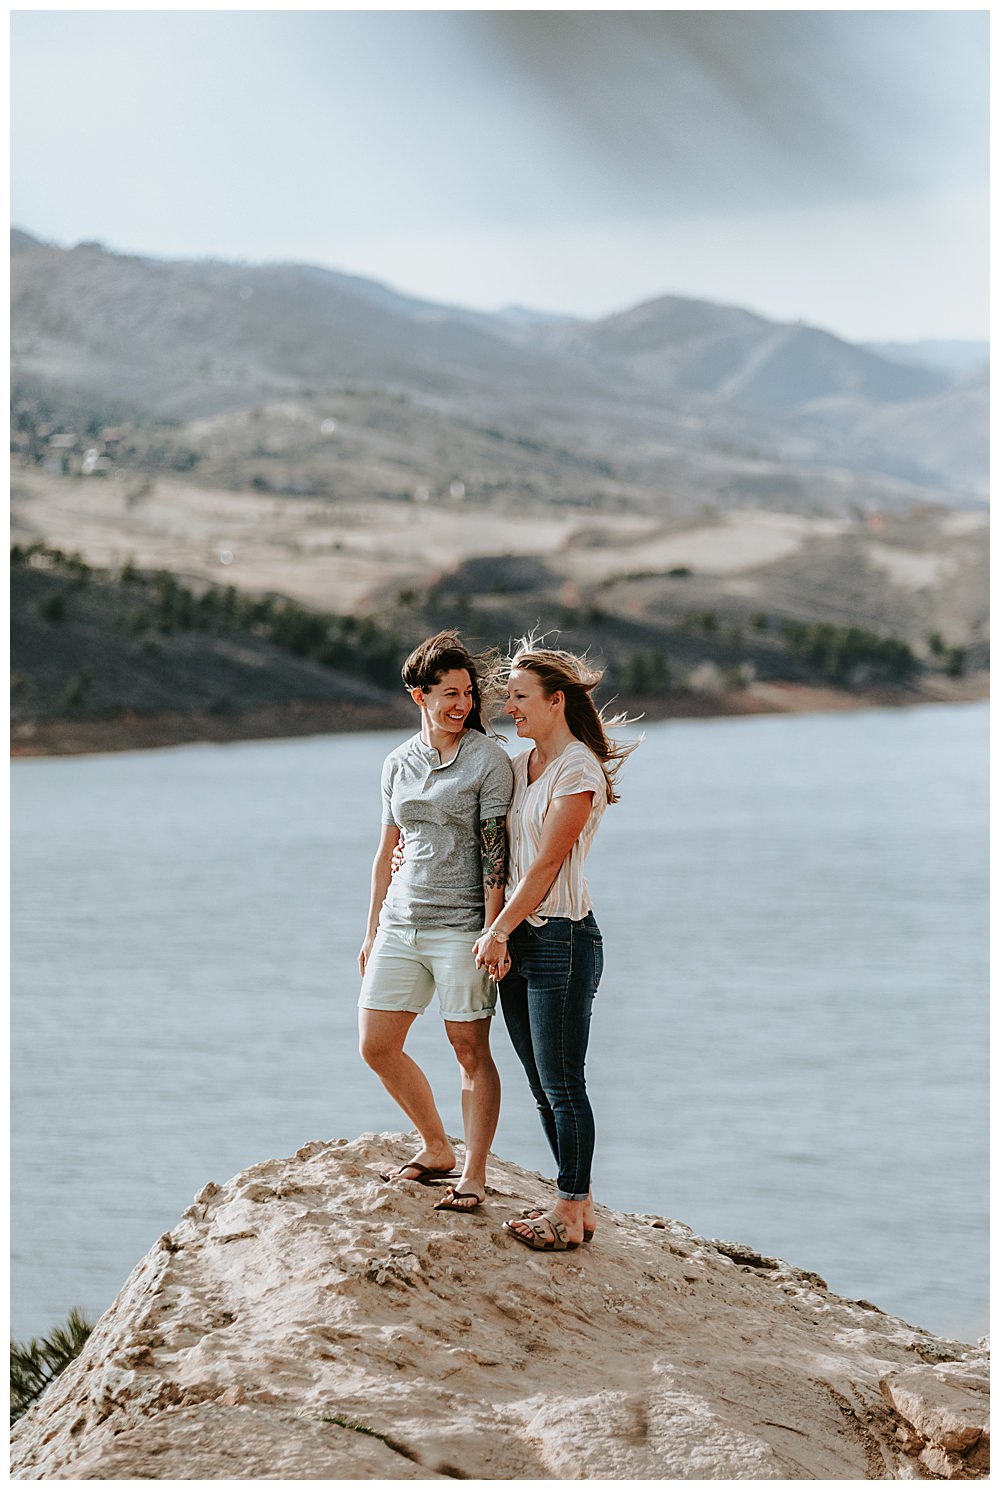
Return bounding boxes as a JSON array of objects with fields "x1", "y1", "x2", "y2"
[{"x1": 13, "y1": 1134, "x2": 988, "y2": 1480}]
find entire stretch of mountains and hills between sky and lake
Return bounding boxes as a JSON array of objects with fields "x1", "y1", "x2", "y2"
[{"x1": 10, "y1": 232, "x2": 988, "y2": 749}]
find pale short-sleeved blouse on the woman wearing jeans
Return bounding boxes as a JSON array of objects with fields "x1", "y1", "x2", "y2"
[{"x1": 507, "y1": 741, "x2": 608, "y2": 927}]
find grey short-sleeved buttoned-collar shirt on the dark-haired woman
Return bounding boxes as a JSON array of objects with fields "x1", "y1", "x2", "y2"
[{"x1": 379, "y1": 730, "x2": 514, "y2": 931}]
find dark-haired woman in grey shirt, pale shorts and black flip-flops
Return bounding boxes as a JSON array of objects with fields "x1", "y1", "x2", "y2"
[{"x1": 358, "y1": 632, "x2": 513, "y2": 1211}]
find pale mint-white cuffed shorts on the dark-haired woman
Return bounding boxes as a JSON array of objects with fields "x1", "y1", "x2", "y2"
[{"x1": 358, "y1": 927, "x2": 496, "y2": 1022}]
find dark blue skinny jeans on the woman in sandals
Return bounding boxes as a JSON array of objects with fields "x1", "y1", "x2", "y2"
[{"x1": 499, "y1": 910, "x2": 604, "y2": 1201}]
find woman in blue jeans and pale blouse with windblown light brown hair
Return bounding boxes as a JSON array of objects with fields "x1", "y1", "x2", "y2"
[{"x1": 475, "y1": 638, "x2": 639, "y2": 1252}]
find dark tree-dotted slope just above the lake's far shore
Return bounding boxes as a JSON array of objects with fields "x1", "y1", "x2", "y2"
[{"x1": 10, "y1": 544, "x2": 967, "y2": 749}]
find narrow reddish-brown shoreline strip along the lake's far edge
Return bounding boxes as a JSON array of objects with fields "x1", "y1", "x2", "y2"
[{"x1": 10, "y1": 672, "x2": 990, "y2": 760}]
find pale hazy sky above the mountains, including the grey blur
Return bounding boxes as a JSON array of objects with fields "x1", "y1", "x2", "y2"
[{"x1": 12, "y1": 10, "x2": 988, "y2": 340}]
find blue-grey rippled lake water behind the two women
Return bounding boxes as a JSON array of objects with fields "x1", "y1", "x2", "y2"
[{"x1": 12, "y1": 705, "x2": 987, "y2": 1340}]
